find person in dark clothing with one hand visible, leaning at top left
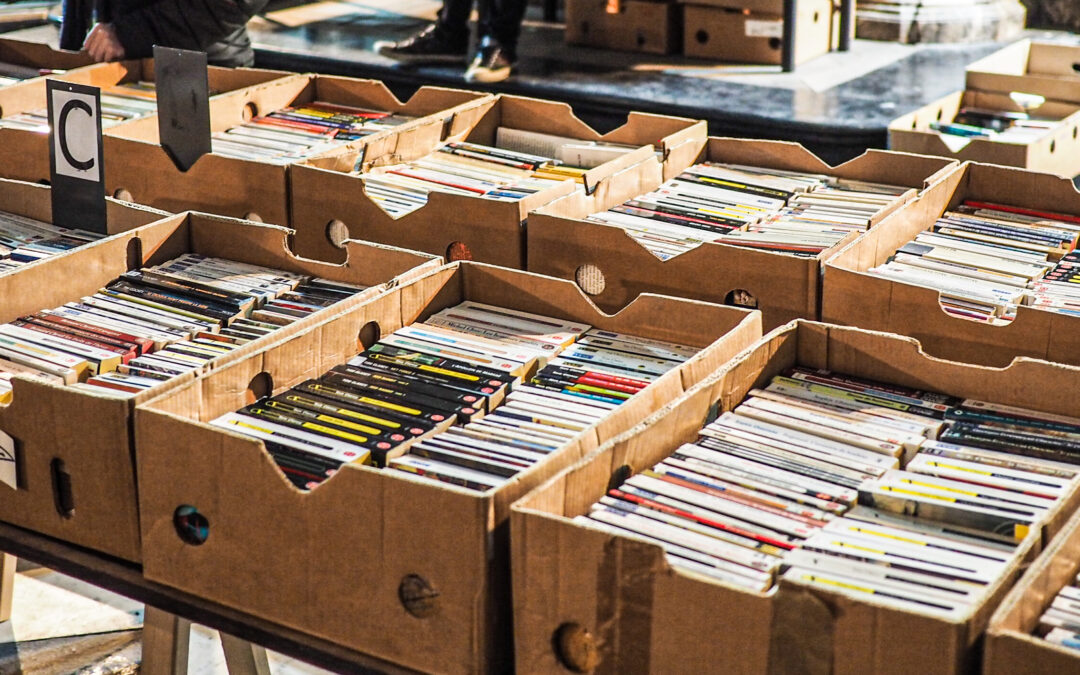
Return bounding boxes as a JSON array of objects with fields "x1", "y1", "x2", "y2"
[{"x1": 60, "y1": 0, "x2": 268, "y2": 67}]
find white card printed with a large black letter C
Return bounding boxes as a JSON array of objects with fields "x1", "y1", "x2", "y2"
[{"x1": 50, "y1": 90, "x2": 102, "y2": 183}]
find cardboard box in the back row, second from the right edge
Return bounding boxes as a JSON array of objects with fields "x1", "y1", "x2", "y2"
[{"x1": 526, "y1": 138, "x2": 955, "y2": 329}]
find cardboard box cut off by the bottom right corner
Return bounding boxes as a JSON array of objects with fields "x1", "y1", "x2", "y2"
[{"x1": 983, "y1": 494, "x2": 1080, "y2": 675}]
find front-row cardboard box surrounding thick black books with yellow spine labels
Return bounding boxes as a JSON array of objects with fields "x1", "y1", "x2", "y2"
[{"x1": 136, "y1": 262, "x2": 760, "y2": 673}]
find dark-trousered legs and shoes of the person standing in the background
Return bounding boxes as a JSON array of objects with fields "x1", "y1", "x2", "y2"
[{"x1": 375, "y1": 0, "x2": 528, "y2": 82}]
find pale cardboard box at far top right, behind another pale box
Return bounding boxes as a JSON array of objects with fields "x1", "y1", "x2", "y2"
[{"x1": 967, "y1": 40, "x2": 1080, "y2": 104}]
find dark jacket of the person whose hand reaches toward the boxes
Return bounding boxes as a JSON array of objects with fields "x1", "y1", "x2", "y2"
[{"x1": 64, "y1": 0, "x2": 268, "y2": 66}]
